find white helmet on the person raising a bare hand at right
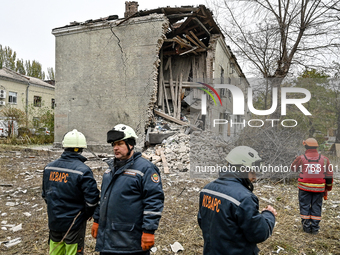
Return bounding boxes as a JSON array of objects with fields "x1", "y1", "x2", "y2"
[{"x1": 226, "y1": 146, "x2": 262, "y2": 167}]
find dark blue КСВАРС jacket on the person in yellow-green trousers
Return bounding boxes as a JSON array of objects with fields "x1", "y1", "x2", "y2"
[{"x1": 42, "y1": 151, "x2": 99, "y2": 232}]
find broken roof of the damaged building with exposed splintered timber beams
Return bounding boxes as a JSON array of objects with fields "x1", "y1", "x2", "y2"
[{"x1": 53, "y1": 5, "x2": 223, "y2": 55}]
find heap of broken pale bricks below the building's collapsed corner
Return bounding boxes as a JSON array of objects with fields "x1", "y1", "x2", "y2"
[{"x1": 143, "y1": 117, "x2": 232, "y2": 173}]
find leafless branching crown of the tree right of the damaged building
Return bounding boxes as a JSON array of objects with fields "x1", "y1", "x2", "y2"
[{"x1": 210, "y1": 0, "x2": 340, "y2": 107}]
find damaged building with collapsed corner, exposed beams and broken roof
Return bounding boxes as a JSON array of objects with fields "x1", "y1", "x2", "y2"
[{"x1": 52, "y1": 2, "x2": 249, "y2": 149}]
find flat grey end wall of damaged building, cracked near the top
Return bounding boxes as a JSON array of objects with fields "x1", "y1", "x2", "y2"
[{"x1": 53, "y1": 14, "x2": 168, "y2": 151}]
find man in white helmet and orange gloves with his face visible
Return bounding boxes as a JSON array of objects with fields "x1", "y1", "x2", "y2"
[{"x1": 91, "y1": 124, "x2": 164, "y2": 255}]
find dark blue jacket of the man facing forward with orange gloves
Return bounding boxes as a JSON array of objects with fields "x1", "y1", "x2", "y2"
[{"x1": 93, "y1": 153, "x2": 164, "y2": 253}]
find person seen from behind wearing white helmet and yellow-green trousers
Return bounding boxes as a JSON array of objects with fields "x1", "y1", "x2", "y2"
[{"x1": 42, "y1": 129, "x2": 99, "y2": 255}]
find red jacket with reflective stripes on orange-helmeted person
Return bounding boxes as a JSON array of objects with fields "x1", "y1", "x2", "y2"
[{"x1": 291, "y1": 149, "x2": 333, "y2": 192}]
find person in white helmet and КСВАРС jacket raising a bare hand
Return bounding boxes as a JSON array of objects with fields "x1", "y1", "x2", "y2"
[{"x1": 197, "y1": 146, "x2": 277, "y2": 255}]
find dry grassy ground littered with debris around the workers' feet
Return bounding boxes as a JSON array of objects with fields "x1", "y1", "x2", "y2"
[{"x1": 0, "y1": 145, "x2": 340, "y2": 255}]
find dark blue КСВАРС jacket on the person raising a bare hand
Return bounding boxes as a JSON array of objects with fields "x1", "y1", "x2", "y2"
[{"x1": 197, "y1": 178, "x2": 275, "y2": 255}]
